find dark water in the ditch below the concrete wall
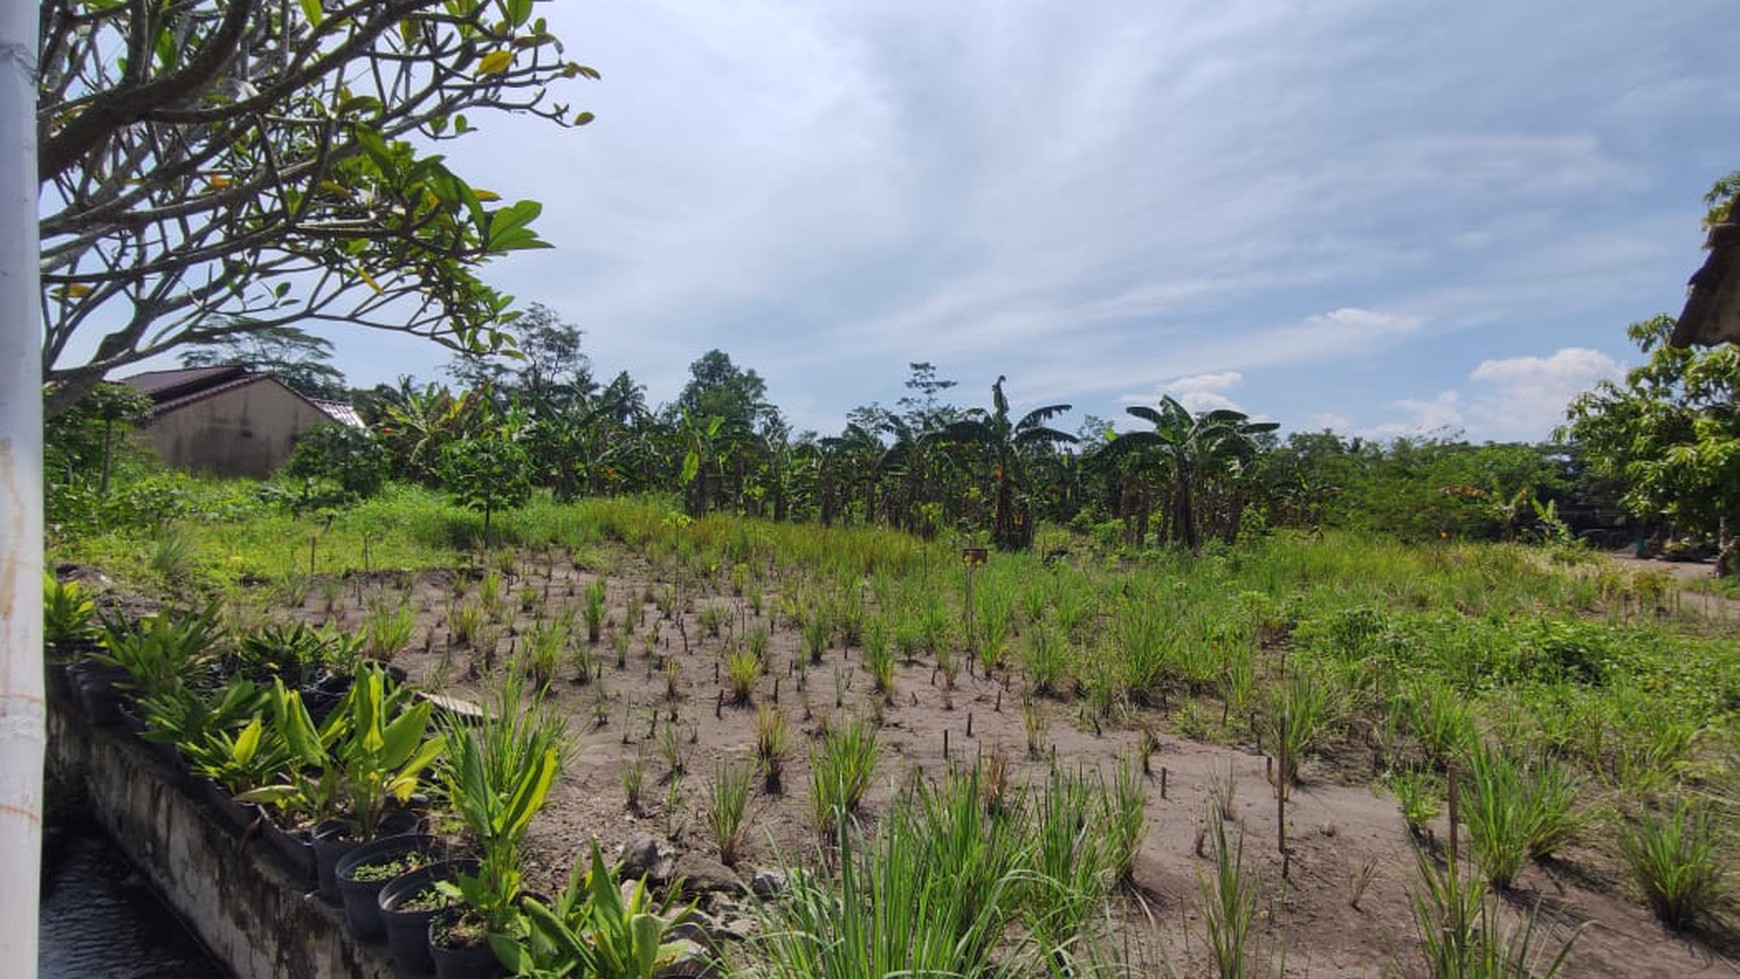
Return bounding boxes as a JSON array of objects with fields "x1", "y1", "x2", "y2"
[{"x1": 38, "y1": 828, "x2": 230, "y2": 979}]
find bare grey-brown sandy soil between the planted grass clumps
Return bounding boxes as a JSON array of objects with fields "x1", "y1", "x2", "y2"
[{"x1": 278, "y1": 556, "x2": 1740, "y2": 979}]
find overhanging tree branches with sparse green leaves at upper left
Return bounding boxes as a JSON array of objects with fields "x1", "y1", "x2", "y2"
[{"x1": 37, "y1": 0, "x2": 597, "y2": 416}]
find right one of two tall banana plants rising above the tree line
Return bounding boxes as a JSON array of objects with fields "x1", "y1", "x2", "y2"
[{"x1": 1107, "y1": 395, "x2": 1281, "y2": 551}]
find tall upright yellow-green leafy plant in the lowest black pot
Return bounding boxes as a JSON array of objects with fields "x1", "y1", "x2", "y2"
[{"x1": 430, "y1": 666, "x2": 566, "y2": 979}]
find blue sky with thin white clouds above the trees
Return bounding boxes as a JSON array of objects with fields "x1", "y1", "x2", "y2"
[{"x1": 331, "y1": 0, "x2": 1740, "y2": 440}]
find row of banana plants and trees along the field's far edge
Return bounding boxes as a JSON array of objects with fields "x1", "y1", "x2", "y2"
[{"x1": 50, "y1": 306, "x2": 1709, "y2": 549}]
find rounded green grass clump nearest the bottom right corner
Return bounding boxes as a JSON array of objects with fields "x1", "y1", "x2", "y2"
[{"x1": 1620, "y1": 800, "x2": 1728, "y2": 929}]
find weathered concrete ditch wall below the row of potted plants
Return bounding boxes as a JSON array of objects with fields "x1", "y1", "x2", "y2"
[{"x1": 49, "y1": 699, "x2": 395, "y2": 979}]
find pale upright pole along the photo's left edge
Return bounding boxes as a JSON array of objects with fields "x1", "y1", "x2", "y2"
[{"x1": 0, "y1": 0, "x2": 47, "y2": 976}]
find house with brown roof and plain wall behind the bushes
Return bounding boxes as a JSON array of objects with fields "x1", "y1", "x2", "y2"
[{"x1": 120, "y1": 365, "x2": 362, "y2": 478}]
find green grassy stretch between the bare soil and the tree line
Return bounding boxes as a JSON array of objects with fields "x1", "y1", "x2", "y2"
[{"x1": 49, "y1": 482, "x2": 1740, "y2": 966}]
